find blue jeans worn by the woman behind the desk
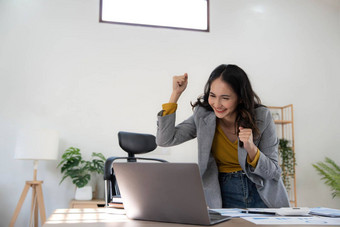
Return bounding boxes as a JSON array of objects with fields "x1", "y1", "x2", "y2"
[{"x1": 218, "y1": 171, "x2": 267, "y2": 208}]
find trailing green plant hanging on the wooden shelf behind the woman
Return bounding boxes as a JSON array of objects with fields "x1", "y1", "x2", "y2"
[{"x1": 279, "y1": 139, "x2": 296, "y2": 191}]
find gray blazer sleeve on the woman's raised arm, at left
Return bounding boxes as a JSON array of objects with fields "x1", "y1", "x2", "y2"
[{"x1": 156, "y1": 113, "x2": 196, "y2": 147}]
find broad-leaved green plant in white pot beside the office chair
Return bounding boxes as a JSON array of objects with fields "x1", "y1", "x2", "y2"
[{"x1": 57, "y1": 147, "x2": 106, "y2": 200}]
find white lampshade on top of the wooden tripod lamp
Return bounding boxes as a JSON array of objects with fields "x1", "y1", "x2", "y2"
[{"x1": 14, "y1": 129, "x2": 59, "y2": 160}]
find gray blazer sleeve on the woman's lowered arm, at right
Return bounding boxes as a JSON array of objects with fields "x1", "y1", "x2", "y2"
[{"x1": 247, "y1": 107, "x2": 282, "y2": 181}]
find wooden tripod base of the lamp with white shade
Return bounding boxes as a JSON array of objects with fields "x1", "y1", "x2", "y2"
[{"x1": 9, "y1": 180, "x2": 46, "y2": 227}]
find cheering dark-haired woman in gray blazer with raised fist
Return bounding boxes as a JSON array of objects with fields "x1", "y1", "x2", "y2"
[{"x1": 156, "y1": 65, "x2": 289, "y2": 208}]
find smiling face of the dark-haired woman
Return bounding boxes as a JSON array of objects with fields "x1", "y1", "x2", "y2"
[{"x1": 208, "y1": 77, "x2": 238, "y2": 121}]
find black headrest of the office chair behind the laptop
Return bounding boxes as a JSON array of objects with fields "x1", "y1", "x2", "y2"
[{"x1": 118, "y1": 131, "x2": 157, "y2": 154}]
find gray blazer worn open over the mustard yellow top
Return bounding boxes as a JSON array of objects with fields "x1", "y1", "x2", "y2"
[{"x1": 156, "y1": 107, "x2": 289, "y2": 208}]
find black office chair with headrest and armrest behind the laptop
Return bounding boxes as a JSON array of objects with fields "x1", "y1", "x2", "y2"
[{"x1": 104, "y1": 131, "x2": 167, "y2": 207}]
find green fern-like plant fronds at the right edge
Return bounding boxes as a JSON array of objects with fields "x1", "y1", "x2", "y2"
[{"x1": 312, "y1": 157, "x2": 340, "y2": 198}]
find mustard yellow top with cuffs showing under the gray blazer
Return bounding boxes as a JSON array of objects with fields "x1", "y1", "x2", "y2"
[{"x1": 162, "y1": 103, "x2": 260, "y2": 173}]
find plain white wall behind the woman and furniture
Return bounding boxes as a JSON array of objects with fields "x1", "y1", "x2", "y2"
[{"x1": 0, "y1": 0, "x2": 340, "y2": 226}]
